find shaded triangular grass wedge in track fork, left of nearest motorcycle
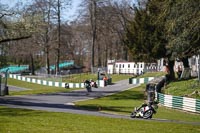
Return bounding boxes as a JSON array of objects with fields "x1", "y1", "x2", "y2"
[{"x1": 77, "y1": 89, "x2": 144, "y2": 113}]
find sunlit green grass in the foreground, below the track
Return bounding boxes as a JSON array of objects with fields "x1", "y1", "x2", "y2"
[{"x1": 0, "y1": 107, "x2": 200, "y2": 133}]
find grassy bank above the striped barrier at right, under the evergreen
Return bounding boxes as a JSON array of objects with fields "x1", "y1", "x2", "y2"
[{"x1": 165, "y1": 79, "x2": 200, "y2": 99}]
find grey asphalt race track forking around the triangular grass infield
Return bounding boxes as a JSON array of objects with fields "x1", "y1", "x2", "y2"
[{"x1": 0, "y1": 80, "x2": 200, "y2": 125}]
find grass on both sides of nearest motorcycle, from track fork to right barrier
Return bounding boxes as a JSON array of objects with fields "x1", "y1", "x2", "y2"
[{"x1": 76, "y1": 85, "x2": 200, "y2": 121}]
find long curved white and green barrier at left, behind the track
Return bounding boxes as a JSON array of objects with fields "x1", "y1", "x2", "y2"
[{"x1": 9, "y1": 74, "x2": 84, "y2": 88}]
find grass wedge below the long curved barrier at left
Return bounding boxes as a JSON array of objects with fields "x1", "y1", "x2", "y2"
[{"x1": 8, "y1": 78, "x2": 74, "y2": 95}]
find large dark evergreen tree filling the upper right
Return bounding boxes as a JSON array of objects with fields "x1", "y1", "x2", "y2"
[{"x1": 125, "y1": 0, "x2": 200, "y2": 79}]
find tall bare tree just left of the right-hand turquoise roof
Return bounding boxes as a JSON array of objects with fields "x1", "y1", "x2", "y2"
[{"x1": 25, "y1": 0, "x2": 55, "y2": 74}]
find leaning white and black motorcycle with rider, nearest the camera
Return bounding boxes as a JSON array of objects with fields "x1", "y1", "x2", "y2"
[{"x1": 131, "y1": 102, "x2": 158, "y2": 119}]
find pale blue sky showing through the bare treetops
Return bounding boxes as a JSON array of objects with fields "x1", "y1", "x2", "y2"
[{"x1": 0, "y1": 0, "x2": 82, "y2": 20}]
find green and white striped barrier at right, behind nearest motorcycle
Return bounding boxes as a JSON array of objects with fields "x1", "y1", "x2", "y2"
[{"x1": 157, "y1": 93, "x2": 200, "y2": 113}]
